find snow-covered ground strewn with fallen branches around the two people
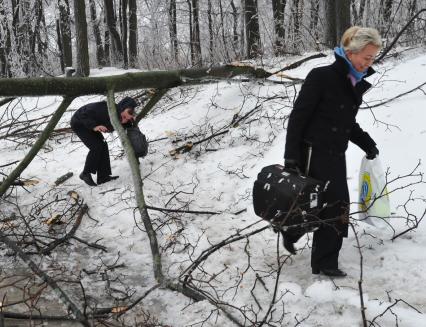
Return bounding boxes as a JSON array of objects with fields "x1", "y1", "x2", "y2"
[{"x1": 0, "y1": 49, "x2": 426, "y2": 327}]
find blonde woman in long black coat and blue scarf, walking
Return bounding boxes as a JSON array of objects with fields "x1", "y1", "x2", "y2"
[{"x1": 283, "y1": 26, "x2": 382, "y2": 277}]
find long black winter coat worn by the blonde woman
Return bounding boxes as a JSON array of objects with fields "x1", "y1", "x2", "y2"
[{"x1": 284, "y1": 56, "x2": 375, "y2": 236}]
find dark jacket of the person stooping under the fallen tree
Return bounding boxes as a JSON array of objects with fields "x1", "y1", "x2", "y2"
[{"x1": 71, "y1": 101, "x2": 131, "y2": 132}]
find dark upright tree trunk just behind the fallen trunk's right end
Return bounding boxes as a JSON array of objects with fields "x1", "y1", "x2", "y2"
[{"x1": 245, "y1": 0, "x2": 261, "y2": 59}]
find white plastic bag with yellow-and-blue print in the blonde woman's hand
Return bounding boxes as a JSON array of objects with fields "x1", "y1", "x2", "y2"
[{"x1": 359, "y1": 156, "x2": 390, "y2": 225}]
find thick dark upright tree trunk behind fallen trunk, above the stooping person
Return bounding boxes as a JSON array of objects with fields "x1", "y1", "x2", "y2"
[{"x1": 74, "y1": 0, "x2": 90, "y2": 76}]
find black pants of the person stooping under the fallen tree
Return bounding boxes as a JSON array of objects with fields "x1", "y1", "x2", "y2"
[{"x1": 71, "y1": 124, "x2": 111, "y2": 180}]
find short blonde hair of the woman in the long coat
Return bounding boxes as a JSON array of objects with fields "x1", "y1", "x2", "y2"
[{"x1": 340, "y1": 26, "x2": 382, "y2": 53}]
